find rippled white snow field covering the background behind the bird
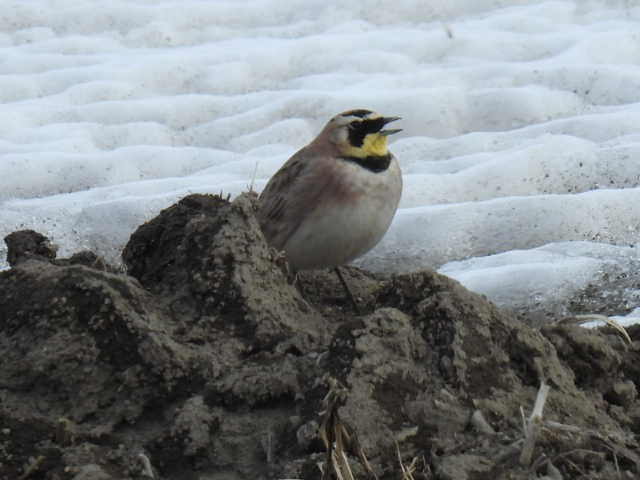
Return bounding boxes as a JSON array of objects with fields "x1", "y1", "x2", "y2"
[{"x1": 0, "y1": 0, "x2": 640, "y2": 317}]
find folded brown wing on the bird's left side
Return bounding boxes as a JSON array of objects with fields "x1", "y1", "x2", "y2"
[{"x1": 258, "y1": 149, "x2": 330, "y2": 249}]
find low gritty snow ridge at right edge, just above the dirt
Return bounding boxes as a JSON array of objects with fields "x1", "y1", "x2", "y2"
[{"x1": 439, "y1": 242, "x2": 640, "y2": 318}]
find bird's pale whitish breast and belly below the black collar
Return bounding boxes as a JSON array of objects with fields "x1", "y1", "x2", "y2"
[{"x1": 284, "y1": 159, "x2": 402, "y2": 270}]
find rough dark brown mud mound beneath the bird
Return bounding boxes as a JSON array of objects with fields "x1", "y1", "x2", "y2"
[{"x1": 0, "y1": 195, "x2": 640, "y2": 480}]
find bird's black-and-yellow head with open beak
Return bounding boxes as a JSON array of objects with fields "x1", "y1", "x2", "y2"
[{"x1": 323, "y1": 110, "x2": 401, "y2": 159}]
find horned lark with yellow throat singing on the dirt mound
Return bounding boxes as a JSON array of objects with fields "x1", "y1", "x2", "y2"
[{"x1": 257, "y1": 109, "x2": 402, "y2": 304}]
